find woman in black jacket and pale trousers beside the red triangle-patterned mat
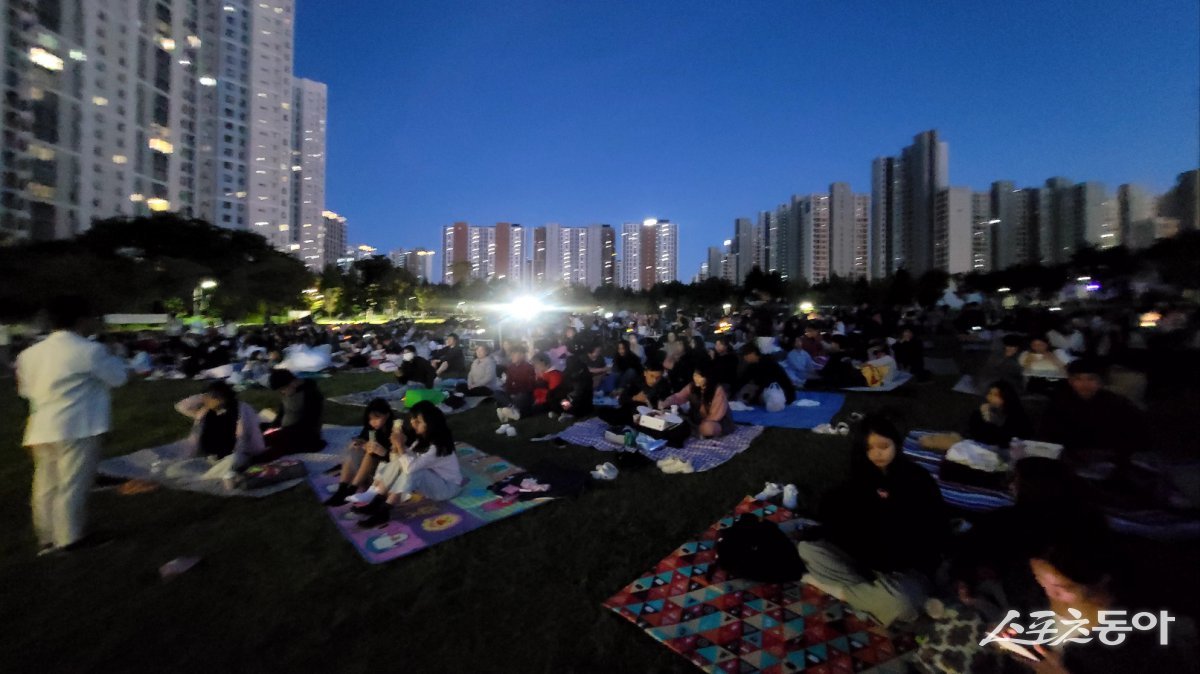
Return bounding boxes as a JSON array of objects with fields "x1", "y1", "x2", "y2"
[{"x1": 797, "y1": 415, "x2": 949, "y2": 626}]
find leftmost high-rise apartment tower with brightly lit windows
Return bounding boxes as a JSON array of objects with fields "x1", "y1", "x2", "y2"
[{"x1": 0, "y1": 0, "x2": 202, "y2": 241}]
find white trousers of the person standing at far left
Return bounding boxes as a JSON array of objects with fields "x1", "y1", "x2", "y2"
[{"x1": 30, "y1": 435, "x2": 100, "y2": 547}]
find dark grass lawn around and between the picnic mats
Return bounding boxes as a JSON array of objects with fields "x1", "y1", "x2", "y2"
[{"x1": 0, "y1": 364, "x2": 1196, "y2": 673}]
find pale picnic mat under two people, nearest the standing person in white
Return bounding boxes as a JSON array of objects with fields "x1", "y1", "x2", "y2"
[{"x1": 96, "y1": 426, "x2": 361, "y2": 498}]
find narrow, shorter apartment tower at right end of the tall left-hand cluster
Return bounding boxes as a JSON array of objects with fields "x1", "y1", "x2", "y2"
[{"x1": 290, "y1": 78, "x2": 332, "y2": 271}]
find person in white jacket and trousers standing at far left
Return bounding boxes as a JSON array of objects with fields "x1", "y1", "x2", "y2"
[{"x1": 17, "y1": 296, "x2": 128, "y2": 554}]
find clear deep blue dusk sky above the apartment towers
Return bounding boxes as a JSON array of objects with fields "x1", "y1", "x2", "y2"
[{"x1": 295, "y1": 0, "x2": 1200, "y2": 281}]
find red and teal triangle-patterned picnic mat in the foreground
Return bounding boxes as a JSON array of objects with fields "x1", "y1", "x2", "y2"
[{"x1": 604, "y1": 497, "x2": 916, "y2": 674}]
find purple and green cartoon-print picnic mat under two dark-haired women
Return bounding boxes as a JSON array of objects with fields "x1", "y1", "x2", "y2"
[{"x1": 308, "y1": 443, "x2": 547, "y2": 564}]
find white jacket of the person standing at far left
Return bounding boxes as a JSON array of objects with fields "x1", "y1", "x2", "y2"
[{"x1": 17, "y1": 330, "x2": 128, "y2": 445}]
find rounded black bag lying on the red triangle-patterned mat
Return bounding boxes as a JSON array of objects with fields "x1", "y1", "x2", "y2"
[{"x1": 716, "y1": 514, "x2": 805, "y2": 583}]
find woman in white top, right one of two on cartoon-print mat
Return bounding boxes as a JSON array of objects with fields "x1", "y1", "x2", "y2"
[{"x1": 355, "y1": 401, "x2": 462, "y2": 529}]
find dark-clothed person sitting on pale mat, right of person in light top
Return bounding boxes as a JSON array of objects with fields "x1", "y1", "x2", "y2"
[{"x1": 259, "y1": 369, "x2": 325, "y2": 463}]
